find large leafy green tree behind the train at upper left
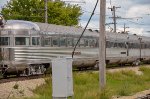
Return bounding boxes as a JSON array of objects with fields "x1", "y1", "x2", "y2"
[{"x1": 1, "y1": 0, "x2": 82, "y2": 26}]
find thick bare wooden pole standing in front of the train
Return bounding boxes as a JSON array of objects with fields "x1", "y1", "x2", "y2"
[{"x1": 99, "y1": 0, "x2": 106, "y2": 90}]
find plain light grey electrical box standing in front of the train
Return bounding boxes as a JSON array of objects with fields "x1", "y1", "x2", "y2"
[{"x1": 52, "y1": 58, "x2": 73, "y2": 98}]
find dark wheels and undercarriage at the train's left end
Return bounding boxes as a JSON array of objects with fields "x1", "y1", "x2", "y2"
[{"x1": 1, "y1": 64, "x2": 49, "y2": 78}]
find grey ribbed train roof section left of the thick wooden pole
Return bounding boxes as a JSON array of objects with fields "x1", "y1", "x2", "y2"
[{"x1": 36, "y1": 22, "x2": 98, "y2": 37}]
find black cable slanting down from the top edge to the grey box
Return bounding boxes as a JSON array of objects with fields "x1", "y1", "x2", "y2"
[{"x1": 72, "y1": 0, "x2": 99, "y2": 58}]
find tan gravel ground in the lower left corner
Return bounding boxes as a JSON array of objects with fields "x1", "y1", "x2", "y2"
[{"x1": 0, "y1": 78, "x2": 45, "y2": 99}]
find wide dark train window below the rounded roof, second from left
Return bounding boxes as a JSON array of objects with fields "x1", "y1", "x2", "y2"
[{"x1": 15, "y1": 37, "x2": 30, "y2": 45}]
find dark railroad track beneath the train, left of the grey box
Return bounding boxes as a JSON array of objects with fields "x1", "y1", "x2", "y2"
[{"x1": 0, "y1": 75, "x2": 44, "y2": 84}]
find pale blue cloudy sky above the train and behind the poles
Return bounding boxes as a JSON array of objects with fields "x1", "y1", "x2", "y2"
[{"x1": 0, "y1": 0, "x2": 150, "y2": 36}]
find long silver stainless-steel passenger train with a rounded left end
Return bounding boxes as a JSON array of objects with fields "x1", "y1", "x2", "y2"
[{"x1": 0, "y1": 20, "x2": 150, "y2": 77}]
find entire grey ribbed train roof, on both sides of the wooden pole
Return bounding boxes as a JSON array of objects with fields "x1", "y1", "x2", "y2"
[{"x1": 36, "y1": 22, "x2": 150, "y2": 42}]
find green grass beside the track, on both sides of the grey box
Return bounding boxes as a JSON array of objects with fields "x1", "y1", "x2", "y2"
[{"x1": 27, "y1": 67, "x2": 150, "y2": 99}]
